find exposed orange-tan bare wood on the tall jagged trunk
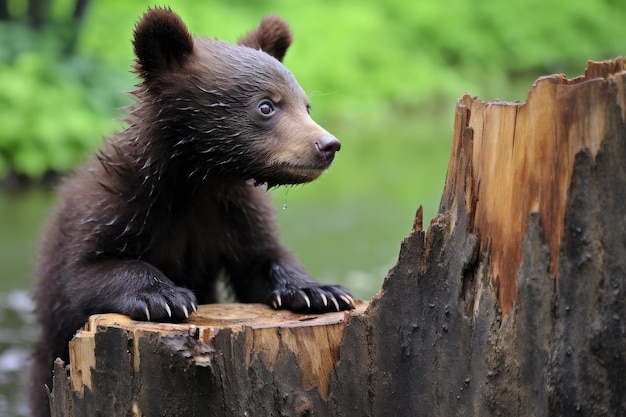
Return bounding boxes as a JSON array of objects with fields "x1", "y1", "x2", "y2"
[{"x1": 444, "y1": 58, "x2": 626, "y2": 314}]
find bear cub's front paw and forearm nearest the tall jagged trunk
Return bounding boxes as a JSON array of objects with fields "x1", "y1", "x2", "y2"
[{"x1": 231, "y1": 250, "x2": 354, "y2": 313}]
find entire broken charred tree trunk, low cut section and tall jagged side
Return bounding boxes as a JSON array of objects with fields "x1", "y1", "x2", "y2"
[{"x1": 51, "y1": 58, "x2": 626, "y2": 416}]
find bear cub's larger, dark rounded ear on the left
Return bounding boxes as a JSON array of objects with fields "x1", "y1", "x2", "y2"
[{"x1": 133, "y1": 8, "x2": 193, "y2": 79}]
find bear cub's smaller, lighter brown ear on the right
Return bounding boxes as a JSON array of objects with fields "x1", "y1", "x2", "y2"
[{"x1": 237, "y1": 16, "x2": 293, "y2": 62}]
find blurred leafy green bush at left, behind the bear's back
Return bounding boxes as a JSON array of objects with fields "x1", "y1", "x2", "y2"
[{"x1": 0, "y1": 24, "x2": 128, "y2": 179}]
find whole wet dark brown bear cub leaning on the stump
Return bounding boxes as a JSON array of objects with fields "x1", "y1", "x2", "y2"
[{"x1": 31, "y1": 8, "x2": 354, "y2": 416}]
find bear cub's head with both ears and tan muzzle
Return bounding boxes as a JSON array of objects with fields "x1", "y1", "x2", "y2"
[{"x1": 130, "y1": 8, "x2": 341, "y2": 186}]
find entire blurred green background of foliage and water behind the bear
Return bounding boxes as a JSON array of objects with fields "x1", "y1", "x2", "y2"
[{"x1": 0, "y1": 0, "x2": 626, "y2": 415}]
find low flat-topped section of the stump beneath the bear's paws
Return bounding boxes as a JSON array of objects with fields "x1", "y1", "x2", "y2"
[{"x1": 51, "y1": 303, "x2": 367, "y2": 417}]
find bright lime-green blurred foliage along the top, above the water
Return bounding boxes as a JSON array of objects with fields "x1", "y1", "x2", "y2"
[{"x1": 81, "y1": 0, "x2": 626, "y2": 116}]
